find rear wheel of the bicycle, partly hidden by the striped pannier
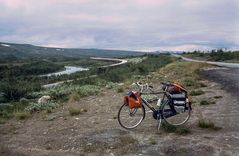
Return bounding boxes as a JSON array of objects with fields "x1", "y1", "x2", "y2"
[{"x1": 162, "y1": 101, "x2": 191, "y2": 126}]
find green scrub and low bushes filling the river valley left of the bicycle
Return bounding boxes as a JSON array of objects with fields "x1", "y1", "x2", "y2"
[{"x1": 0, "y1": 54, "x2": 175, "y2": 121}]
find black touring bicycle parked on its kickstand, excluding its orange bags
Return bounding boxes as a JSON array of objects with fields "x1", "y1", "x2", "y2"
[{"x1": 118, "y1": 82, "x2": 192, "y2": 130}]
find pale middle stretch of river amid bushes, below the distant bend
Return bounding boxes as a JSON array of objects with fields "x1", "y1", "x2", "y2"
[{"x1": 42, "y1": 66, "x2": 89, "y2": 77}]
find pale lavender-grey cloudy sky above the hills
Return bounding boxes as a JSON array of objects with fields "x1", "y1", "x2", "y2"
[{"x1": 0, "y1": 0, "x2": 239, "y2": 51}]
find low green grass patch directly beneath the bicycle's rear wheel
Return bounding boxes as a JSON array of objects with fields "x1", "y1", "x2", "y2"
[{"x1": 161, "y1": 122, "x2": 191, "y2": 135}]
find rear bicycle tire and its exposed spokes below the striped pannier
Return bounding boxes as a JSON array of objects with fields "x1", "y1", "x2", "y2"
[{"x1": 162, "y1": 101, "x2": 191, "y2": 126}]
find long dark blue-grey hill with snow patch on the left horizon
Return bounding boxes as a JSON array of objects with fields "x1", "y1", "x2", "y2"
[{"x1": 0, "y1": 42, "x2": 145, "y2": 60}]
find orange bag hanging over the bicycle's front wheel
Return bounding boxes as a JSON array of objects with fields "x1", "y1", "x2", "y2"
[{"x1": 124, "y1": 91, "x2": 142, "y2": 108}]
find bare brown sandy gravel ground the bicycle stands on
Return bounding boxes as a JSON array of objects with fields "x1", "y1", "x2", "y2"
[{"x1": 0, "y1": 70, "x2": 239, "y2": 156}]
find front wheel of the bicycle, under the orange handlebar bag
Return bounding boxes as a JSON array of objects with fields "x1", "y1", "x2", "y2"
[{"x1": 118, "y1": 104, "x2": 145, "y2": 129}]
